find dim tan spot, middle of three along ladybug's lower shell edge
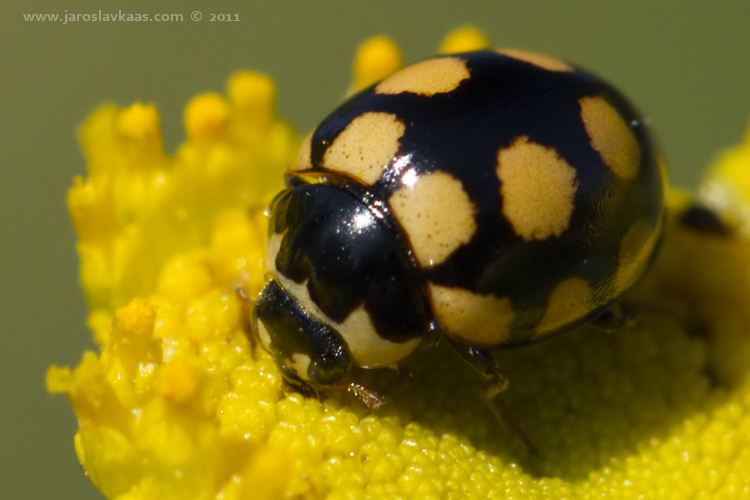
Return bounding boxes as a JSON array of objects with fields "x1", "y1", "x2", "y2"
[{"x1": 536, "y1": 277, "x2": 594, "y2": 336}]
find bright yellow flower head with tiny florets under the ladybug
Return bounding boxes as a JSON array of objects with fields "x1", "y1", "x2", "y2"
[{"x1": 47, "y1": 28, "x2": 750, "y2": 500}]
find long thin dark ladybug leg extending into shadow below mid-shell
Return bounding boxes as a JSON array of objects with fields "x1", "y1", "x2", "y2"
[{"x1": 449, "y1": 340, "x2": 538, "y2": 456}]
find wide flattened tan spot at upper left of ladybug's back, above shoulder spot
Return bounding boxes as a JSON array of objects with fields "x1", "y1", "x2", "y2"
[{"x1": 375, "y1": 57, "x2": 470, "y2": 96}]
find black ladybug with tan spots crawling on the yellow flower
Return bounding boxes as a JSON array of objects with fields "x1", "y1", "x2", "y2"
[{"x1": 253, "y1": 50, "x2": 666, "y2": 404}]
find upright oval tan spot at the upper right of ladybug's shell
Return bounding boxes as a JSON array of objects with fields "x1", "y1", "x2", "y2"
[{"x1": 578, "y1": 97, "x2": 641, "y2": 179}]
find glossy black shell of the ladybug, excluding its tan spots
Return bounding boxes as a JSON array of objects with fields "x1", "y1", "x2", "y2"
[{"x1": 261, "y1": 50, "x2": 665, "y2": 384}]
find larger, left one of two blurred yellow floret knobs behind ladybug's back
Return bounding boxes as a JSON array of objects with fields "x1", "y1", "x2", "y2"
[{"x1": 352, "y1": 36, "x2": 403, "y2": 92}]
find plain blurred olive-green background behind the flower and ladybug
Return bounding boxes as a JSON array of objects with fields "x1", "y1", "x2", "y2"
[{"x1": 0, "y1": 0, "x2": 750, "y2": 500}]
